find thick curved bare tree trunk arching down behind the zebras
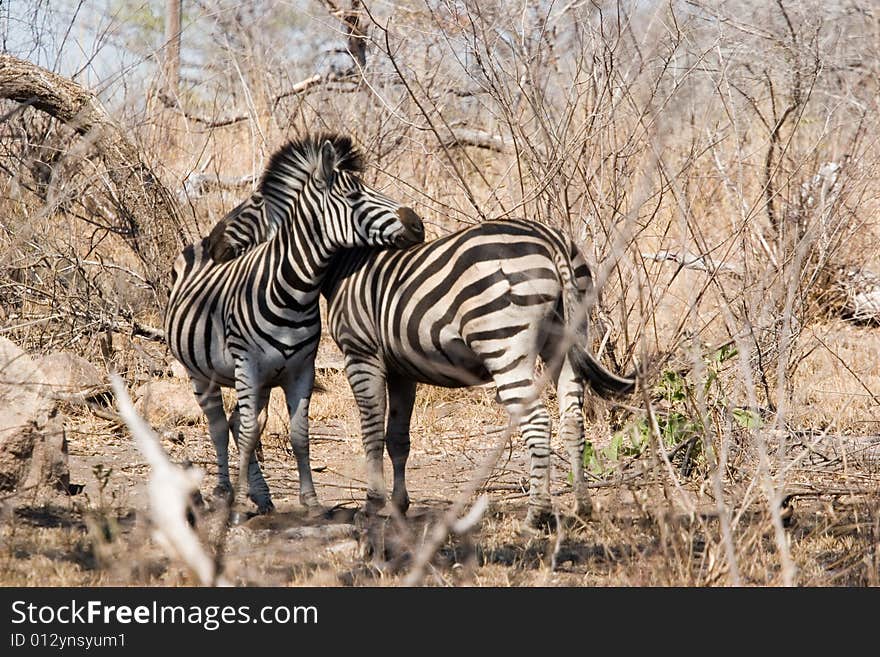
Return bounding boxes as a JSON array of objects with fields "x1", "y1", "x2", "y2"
[{"x1": 0, "y1": 54, "x2": 183, "y2": 307}]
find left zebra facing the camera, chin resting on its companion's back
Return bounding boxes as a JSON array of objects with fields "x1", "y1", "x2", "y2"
[{"x1": 165, "y1": 134, "x2": 424, "y2": 513}]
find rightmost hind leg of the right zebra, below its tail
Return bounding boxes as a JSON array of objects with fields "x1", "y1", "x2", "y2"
[{"x1": 556, "y1": 357, "x2": 593, "y2": 520}]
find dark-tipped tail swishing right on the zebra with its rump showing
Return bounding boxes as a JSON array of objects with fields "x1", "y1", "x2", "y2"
[{"x1": 556, "y1": 243, "x2": 636, "y2": 398}]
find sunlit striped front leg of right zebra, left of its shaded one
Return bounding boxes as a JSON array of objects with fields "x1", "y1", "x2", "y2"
[{"x1": 345, "y1": 357, "x2": 388, "y2": 515}]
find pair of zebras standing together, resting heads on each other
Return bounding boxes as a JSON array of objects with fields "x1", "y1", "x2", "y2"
[{"x1": 165, "y1": 135, "x2": 634, "y2": 526}]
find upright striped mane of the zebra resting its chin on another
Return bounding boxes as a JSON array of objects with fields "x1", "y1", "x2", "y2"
[{"x1": 260, "y1": 133, "x2": 364, "y2": 192}]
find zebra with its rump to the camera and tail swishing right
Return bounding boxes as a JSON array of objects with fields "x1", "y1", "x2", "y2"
[{"x1": 206, "y1": 211, "x2": 635, "y2": 527}]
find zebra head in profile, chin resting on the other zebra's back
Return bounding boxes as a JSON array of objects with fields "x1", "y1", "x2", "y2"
[{"x1": 310, "y1": 136, "x2": 425, "y2": 248}]
